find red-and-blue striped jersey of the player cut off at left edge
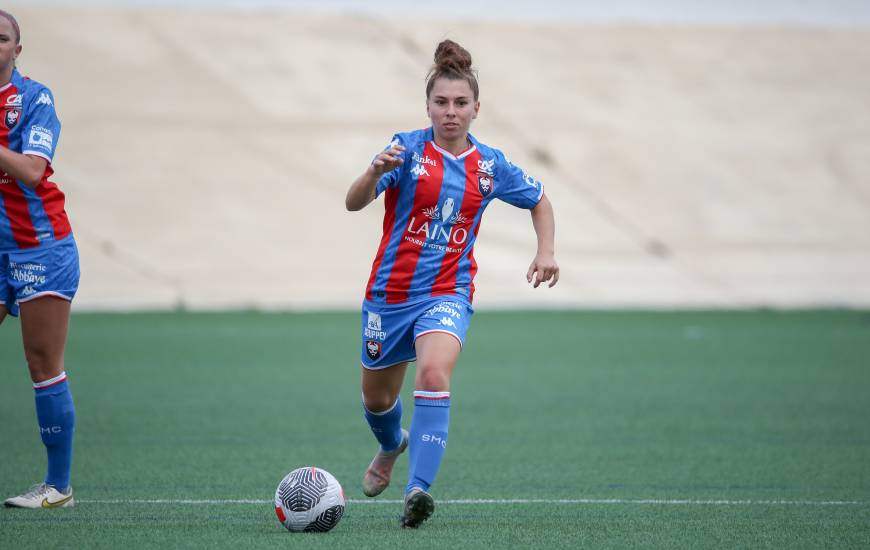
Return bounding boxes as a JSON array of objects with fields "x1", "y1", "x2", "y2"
[{"x1": 0, "y1": 70, "x2": 71, "y2": 252}]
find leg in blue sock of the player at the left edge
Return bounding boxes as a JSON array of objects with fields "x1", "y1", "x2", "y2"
[{"x1": 20, "y1": 296, "x2": 75, "y2": 506}]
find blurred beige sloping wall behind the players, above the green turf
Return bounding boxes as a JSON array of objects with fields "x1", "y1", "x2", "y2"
[{"x1": 4, "y1": 0, "x2": 870, "y2": 311}]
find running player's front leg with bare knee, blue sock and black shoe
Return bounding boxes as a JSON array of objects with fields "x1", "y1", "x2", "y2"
[{"x1": 402, "y1": 332, "x2": 462, "y2": 527}]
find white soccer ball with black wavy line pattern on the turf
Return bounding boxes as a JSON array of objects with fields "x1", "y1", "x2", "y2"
[{"x1": 275, "y1": 466, "x2": 344, "y2": 532}]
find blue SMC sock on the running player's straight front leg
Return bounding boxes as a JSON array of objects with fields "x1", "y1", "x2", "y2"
[{"x1": 405, "y1": 391, "x2": 450, "y2": 494}]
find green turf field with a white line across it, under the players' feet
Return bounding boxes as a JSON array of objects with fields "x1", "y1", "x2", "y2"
[{"x1": 0, "y1": 311, "x2": 870, "y2": 549}]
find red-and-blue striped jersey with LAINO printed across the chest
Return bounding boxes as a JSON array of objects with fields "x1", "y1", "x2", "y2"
[{"x1": 366, "y1": 128, "x2": 544, "y2": 303}]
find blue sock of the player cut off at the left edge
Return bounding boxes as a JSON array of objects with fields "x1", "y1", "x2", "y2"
[{"x1": 33, "y1": 372, "x2": 76, "y2": 491}]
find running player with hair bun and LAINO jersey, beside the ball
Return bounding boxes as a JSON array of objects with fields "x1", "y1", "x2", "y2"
[{"x1": 346, "y1": 40, "x2": 559, "y2": 527}]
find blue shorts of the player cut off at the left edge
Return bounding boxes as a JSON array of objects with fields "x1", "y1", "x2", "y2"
[{"x1": 0, "y1": 235, "x2": 79, "y2": 317}]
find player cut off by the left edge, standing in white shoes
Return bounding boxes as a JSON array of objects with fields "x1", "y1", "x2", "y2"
[{"x1": 0, "y1": 10, "x2": 79, "y2": 508}]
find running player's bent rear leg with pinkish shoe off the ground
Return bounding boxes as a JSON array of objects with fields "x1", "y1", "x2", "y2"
[{"x1": 362, "y1": 362, "x2": 408, "y2": 497}]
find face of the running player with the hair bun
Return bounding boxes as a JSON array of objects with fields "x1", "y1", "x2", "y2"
[{"x1": 426, "y1": 78, "x2": 480, "y2": 147}]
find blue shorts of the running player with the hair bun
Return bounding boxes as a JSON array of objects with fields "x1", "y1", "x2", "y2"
[{"x1": 361, "y1": 295, "x2": 474, "y2": 369}]
